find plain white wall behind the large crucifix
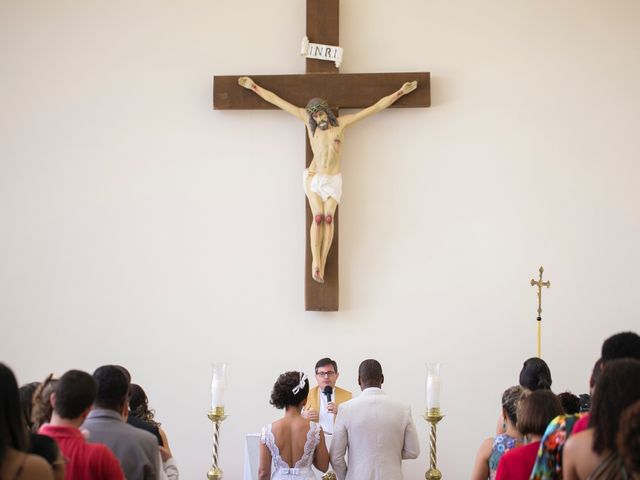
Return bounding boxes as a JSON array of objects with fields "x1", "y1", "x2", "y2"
[{"x1": 0, "y1": 0, "x2": 640, "y2": 479}]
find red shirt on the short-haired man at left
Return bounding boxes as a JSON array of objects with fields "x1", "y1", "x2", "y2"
[{"x1": 38, "y1": 424, "x2": 125, "y2": 480}]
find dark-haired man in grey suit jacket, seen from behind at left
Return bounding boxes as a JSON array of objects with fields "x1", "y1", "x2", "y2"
[{"x1": 81, "y1": 365, "x2": 162, "y2": 480}]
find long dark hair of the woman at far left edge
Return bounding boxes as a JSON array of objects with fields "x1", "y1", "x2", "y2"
[{"x1": 0, "y1": 363, "x2": 27, "y2": 465}]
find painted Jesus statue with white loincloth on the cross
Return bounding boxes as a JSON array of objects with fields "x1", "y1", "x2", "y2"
[{"x1": 238, "y1": 77, "x2": 418, "y2": 283}]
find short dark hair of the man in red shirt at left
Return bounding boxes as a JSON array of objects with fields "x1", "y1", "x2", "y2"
[{"x1": 53, "y1": 370, "x2": 98, "y2": 419}]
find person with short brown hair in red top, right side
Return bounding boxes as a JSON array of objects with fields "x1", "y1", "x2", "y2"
[{"x1": 496, "y1": 389, "x2": 562, "y2": 480}]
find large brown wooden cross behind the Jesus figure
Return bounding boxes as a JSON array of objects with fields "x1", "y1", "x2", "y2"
[{"x1": 213, "y1": 0, "x2": 430, "y2": 311}]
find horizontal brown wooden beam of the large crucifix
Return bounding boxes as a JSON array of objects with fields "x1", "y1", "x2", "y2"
[{"x1": 213, "y1": 72, "x2": 431, "y2": 110}]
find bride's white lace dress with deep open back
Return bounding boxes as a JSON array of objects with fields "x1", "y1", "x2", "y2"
[{"x1": 260, "y1": 422, "x2": 320, "y2": 480}]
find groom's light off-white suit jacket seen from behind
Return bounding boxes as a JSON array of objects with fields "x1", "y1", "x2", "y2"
[{"x1": 330, "y1": 387, "x2": 420, "y2": 480}]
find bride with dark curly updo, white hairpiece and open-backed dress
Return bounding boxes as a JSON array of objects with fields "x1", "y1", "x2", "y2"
[{"x1": 258, "y1": 372, "x2": 329, "y2": 480}]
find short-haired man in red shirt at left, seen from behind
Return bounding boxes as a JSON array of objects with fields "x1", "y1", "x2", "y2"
[{"x1": 40, "y1": 370, "x2": 124, "y2": 480}]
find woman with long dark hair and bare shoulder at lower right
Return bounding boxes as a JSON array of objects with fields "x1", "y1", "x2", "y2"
[{"x1": 562, "y1": 358, "x2": 640, "y2": 480}]
